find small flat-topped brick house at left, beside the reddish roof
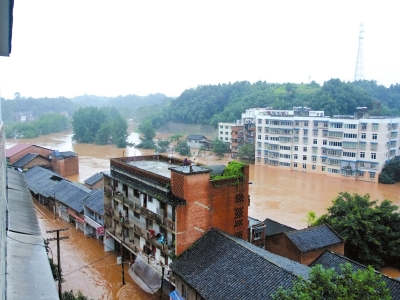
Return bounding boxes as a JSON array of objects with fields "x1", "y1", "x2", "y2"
[{"x1": 50, "y1": 151, "x2": 79, "y2": 177}]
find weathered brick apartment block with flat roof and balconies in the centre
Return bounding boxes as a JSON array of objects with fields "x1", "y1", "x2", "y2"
[{"x1": 104, "y1": 155, "x2": 248, "y2": 284}]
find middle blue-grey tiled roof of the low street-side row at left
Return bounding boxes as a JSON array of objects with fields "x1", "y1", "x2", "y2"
[{"x1": 54, "y1": 180, "x2": 91, "y2": 213}]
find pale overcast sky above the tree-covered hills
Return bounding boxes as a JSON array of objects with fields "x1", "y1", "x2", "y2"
[{"x1": 0, "y1": 0, "x2": 400, "y2": 98}]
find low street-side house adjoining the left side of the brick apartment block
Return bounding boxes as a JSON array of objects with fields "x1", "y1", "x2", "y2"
[{"x1": 83, "y1": 190, "x2": 104, "y2": 239}]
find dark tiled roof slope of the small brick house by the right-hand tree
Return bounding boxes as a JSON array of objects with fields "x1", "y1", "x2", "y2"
[{"x1": 284, "y1": 224, "x2": 343, "y2": 253}]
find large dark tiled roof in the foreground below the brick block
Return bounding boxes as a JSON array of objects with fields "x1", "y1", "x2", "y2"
[{"x1": 171, "y1": 230, "x2": 309, "y2": 299}]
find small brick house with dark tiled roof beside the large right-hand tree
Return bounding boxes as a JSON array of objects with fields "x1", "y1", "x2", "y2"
[{"x1": 266, "y1": 224, "x2": 344, "y2": 265}]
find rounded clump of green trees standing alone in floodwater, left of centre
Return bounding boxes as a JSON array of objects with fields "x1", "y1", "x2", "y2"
[{"x1": 72, "y1": 107, "x2": 128, "y2": 148}]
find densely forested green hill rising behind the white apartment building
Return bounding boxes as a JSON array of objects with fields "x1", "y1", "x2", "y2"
[{"x1": 145, "y1": 79, "x2": 400, "y2": 127}]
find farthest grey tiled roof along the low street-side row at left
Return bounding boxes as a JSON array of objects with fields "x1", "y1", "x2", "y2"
[{"x1": 24, "y1": 166, "x2": 64, "y2": 197}]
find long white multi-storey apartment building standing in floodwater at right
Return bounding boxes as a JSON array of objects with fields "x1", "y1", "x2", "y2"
[{"x1": 255, "y1": 111, "x2": 400, "y2": 182}]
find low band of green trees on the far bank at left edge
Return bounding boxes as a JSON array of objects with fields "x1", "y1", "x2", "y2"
[{"x1": 6, "y1": 113, "x2": 69, "y2": 138}]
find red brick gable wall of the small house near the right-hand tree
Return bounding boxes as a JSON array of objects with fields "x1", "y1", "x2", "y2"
[{"x1": 265, "y1": 233, "x2": 301, "y2": 262}]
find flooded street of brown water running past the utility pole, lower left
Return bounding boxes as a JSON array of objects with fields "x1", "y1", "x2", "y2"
[{"x1": 34, "y1": 202, "x2": 158, "y2": 300}]
